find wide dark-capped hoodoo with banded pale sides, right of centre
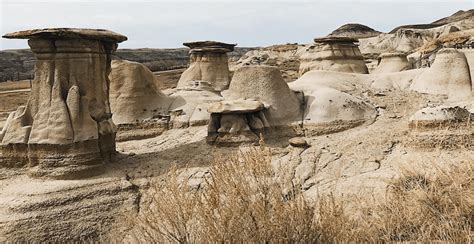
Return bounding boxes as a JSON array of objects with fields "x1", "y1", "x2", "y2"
[{"x1": 299, "y1": 37, "x2": 368, "y2": 76}]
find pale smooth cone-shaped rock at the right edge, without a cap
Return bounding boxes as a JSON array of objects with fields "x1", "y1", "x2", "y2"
[{"x1": 410, "y1": 48, "x2": 472, "y2": 100}]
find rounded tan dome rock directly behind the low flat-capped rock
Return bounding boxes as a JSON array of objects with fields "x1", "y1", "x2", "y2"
[{"x1": 224, "y1": 65, "x2": 300, "y2": 126}]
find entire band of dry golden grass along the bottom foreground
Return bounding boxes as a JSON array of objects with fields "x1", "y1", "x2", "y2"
[{"x1": 123, "y1": 149, "x2": 474, "y2": 243}]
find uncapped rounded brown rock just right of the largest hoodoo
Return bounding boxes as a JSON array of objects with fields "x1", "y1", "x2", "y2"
[{"x1": 109, "y1": 60, "x2": 172, "y2": 125}]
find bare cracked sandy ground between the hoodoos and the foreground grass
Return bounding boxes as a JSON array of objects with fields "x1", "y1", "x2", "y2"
[{"x1": 0, "y1": 73, "x2": 474, "y2": 242}]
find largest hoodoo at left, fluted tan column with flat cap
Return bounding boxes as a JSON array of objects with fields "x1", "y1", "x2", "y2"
[{"x1": 0, "y1": 28, "x2": 127, "y2": 179}]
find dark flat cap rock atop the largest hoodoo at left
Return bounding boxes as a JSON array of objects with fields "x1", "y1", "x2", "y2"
[{"x1": 2, "y1": 28, "x2": 127, "y2": 42}]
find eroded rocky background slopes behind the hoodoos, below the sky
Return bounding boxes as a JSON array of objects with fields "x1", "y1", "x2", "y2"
[{"x1": 236, "y1": 9, "x2": 474, "y2": 76}]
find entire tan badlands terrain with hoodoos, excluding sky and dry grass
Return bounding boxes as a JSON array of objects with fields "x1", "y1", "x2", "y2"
[{"x1": 0, "y1": 8, "x2": 474, "y2": 242}]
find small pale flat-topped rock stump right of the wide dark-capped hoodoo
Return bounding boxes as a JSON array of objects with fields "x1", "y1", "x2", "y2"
[{"x1": 371, "y1": 53, "x2": 412, "y2": 74}]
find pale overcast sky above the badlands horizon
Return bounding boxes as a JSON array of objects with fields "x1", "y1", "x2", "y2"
[{"x1": 0, "y1": 0, "x2": 474, "y2": 50}]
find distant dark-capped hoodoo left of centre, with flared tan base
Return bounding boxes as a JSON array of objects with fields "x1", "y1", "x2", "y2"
[{"x1": 178, "y1": 41, "x2": 237, "y2": 91}]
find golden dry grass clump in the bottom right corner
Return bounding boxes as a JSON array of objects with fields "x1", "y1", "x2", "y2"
[{"x1": 365, "y1": 163, "x2": 474, "y2": 243}]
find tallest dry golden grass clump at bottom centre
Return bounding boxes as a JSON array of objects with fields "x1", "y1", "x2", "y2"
[{"x1": 128, "y1": 149, "x2": 330, "y2": 243}]
